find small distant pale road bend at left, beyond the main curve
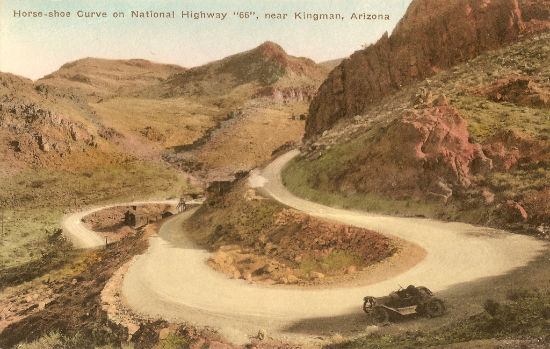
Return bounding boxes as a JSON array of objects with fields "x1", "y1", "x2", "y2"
[{"x1": 61, "y1": 200, "x2": 178, "y2": 249}]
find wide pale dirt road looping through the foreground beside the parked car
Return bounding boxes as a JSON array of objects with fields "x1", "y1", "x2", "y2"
[{"x1": 119, "y1": 151, "x2": 546, "y2": 343}]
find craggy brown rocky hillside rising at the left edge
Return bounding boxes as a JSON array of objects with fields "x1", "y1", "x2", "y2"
[{"x1": 0, "y1": 73, "x2": 116, "y2": 172}]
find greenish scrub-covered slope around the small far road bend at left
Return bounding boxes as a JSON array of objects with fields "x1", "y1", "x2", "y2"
[{"x1": 0, "y1": 161, "x2": 188, "y2": 287}]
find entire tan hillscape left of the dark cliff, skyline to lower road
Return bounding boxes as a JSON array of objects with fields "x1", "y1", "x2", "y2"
[{"x1": 0, "y1": 43, "x2": 327, "y2": 278}]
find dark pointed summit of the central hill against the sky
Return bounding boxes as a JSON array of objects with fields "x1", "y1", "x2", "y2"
[{"x1": 144, "y1": 42, "x2": 327, "y2": 100}]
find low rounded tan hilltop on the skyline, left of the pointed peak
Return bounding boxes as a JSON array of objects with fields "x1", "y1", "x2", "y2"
[{"x1": 38, "y1": 58, "x2": 185, "y2": 98}]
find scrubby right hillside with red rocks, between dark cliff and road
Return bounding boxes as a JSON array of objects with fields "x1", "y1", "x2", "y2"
[{"x1": 285, "y1": 33, "x2": 550, "y2": 236}]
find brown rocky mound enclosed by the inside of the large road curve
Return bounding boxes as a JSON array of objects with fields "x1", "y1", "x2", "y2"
[{"x1": 184, "y1": 181, "x2": 396, "y2": 284}]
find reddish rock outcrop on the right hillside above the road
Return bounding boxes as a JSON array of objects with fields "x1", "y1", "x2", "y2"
[{"x1": 327, "y1": 100, "x2": 492, "y2": 202}]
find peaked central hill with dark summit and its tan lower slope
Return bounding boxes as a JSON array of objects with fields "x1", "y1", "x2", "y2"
[{"x1": 155, "y1": 42, "x2": 328, "y2": 179}]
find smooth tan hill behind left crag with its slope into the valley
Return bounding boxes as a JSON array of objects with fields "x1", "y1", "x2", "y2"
[{"x1": 36, "y1": 58, "x2": 240, "y2": 159}]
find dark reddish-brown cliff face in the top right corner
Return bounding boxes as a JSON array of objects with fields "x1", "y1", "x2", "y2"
[{"x1": 306, "y1": 0, "x2": 550, "y2": 136}]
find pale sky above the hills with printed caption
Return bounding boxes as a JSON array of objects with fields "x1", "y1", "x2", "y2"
[{"x1": 0, "y1": 0, "x2": 411, "y2": 79}]
